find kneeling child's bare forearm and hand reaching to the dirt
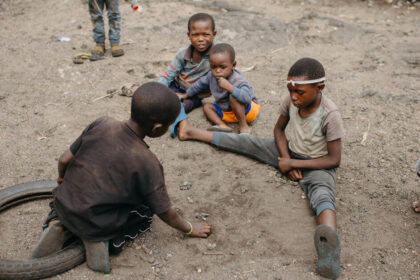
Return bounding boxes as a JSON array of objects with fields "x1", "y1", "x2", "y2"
[{"x1": 158, "y1": 208, "x2": 211, "y2": 238}]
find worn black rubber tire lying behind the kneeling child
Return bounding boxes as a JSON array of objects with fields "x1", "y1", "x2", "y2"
[{"x1": 0, "y1": 181, "x2": 85, "y2": 279}]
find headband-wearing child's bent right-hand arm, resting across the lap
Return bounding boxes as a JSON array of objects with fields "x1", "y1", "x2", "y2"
[{"x1": 279, "y1": 138, "x2": 341, "y2": 173}]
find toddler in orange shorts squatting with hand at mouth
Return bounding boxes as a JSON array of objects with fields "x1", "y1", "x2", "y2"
[{"x1": 178, "y1": 44, "x2": 260, "y2": 133}]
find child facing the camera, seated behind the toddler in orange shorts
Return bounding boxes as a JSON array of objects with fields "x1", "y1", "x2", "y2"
[{"x1": 158, "y1": 13, "x2": 217, "y2": 113}]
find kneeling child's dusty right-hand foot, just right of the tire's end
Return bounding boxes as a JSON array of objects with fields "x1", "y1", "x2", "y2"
[{"x1": 82, "y1": 240, "x2": 111, "y2": 274}]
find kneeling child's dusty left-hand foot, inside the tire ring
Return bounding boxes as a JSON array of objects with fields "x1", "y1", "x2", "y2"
[{"x1": 32, "y1": 222, "x2": 73, "y2": 259}]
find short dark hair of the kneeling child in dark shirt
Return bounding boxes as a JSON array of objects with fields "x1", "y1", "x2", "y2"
[{"x1": 131, "y1": 82, "x2": 181, "y2": 125}]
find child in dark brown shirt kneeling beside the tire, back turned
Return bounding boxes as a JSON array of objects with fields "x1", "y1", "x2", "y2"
[{"x1": 33, "y1": 82, "x2": 210, "y2": 273}]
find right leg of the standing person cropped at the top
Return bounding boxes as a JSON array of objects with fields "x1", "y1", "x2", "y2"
[{"x1": 105, "y1": 0, "x2": 124, "y2": 57}]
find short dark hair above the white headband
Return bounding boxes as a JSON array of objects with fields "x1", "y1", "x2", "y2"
[{"x1": 287, "y1": 57, "x2": 325, "y2": 80}]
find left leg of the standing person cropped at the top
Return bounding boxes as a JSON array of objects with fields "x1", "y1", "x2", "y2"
[{"x1": 89, "y1": 0, "x2": 105, "y2": 55}]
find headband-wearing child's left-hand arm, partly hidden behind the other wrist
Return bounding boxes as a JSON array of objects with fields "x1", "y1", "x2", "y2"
[{"x1": 274, "y1": 114, "x2": 303, "y2": 181}]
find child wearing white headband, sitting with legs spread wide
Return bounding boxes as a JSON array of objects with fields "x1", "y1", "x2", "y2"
[{"x1": 178, "y1": 58, "x2": 344, "y2": 279}]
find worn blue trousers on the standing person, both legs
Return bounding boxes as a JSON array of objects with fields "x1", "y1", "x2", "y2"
[{"x1": 89, "y1": 0, "x2": 121, "y2": 46}]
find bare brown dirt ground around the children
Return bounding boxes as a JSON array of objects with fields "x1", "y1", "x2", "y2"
[{"x1": 0, "y1": 0, "x2": 420, "y2": 280}]
